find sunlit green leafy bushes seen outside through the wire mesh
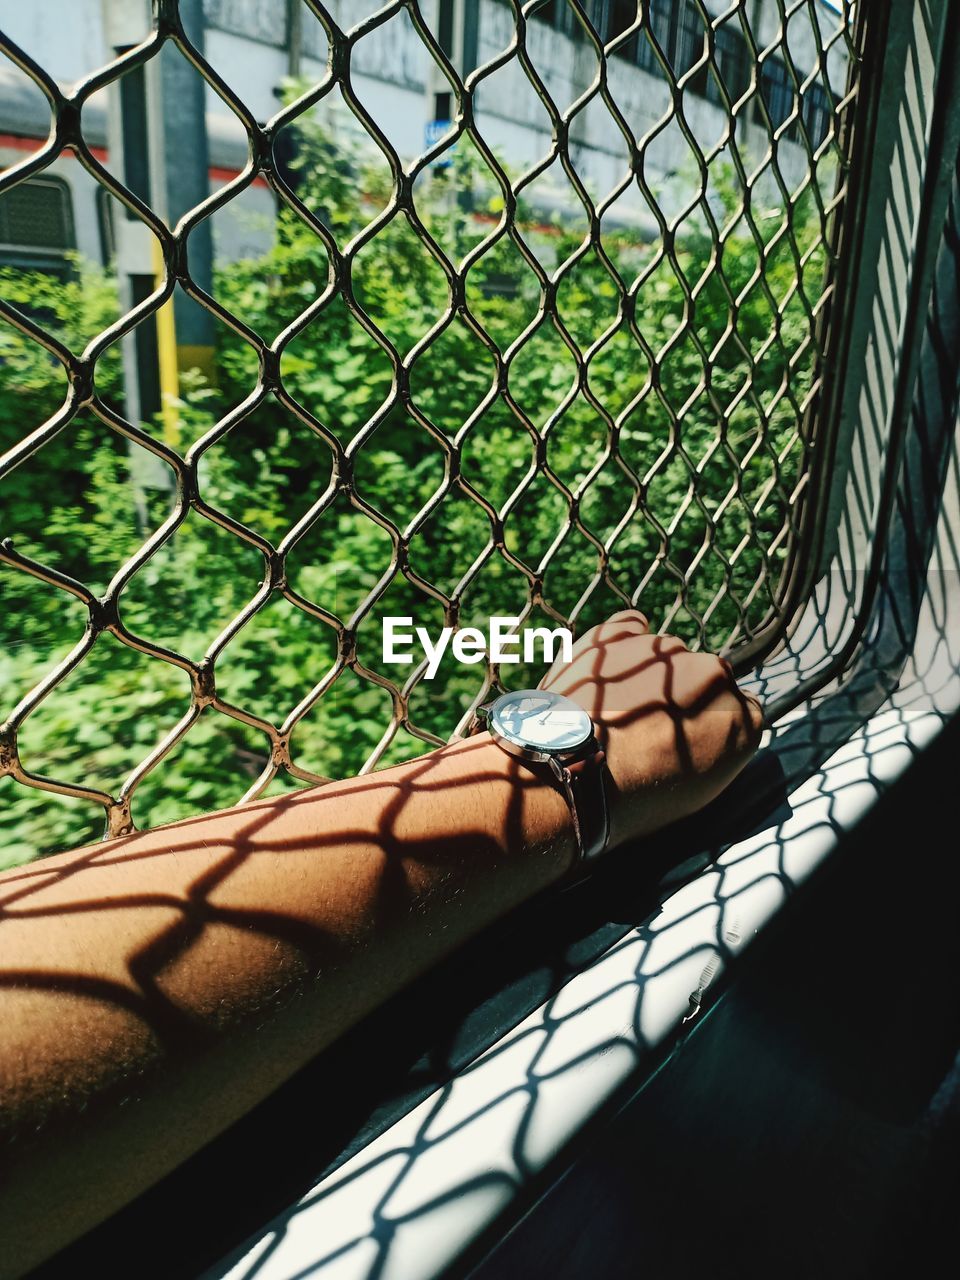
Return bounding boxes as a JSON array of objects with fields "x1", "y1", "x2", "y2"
[{"x1": 0, "y1": 115, "x2": 823, "y2": 865}]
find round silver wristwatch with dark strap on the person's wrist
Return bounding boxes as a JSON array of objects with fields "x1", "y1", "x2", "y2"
[{"x1": 471, "y1": 689, "x2": 611, "y2": 868}]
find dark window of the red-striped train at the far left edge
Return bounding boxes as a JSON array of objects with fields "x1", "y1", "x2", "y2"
[{"x1": 0, "y1": 177, "x2": 77, "y2": 275}]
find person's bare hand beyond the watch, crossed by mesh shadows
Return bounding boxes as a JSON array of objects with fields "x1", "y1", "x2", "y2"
[{"x1": 540, "y1": 609, "x2": 763, "y2": 845}]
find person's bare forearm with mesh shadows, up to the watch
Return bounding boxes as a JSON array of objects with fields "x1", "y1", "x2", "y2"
[{"x1": 0, "y1": 736, "x2": 573, "y2": 1275}]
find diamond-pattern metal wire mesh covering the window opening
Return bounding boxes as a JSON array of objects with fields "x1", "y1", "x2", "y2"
[{"x1": 0, "y1": 0, "x2": 860, "y2": 836}]
